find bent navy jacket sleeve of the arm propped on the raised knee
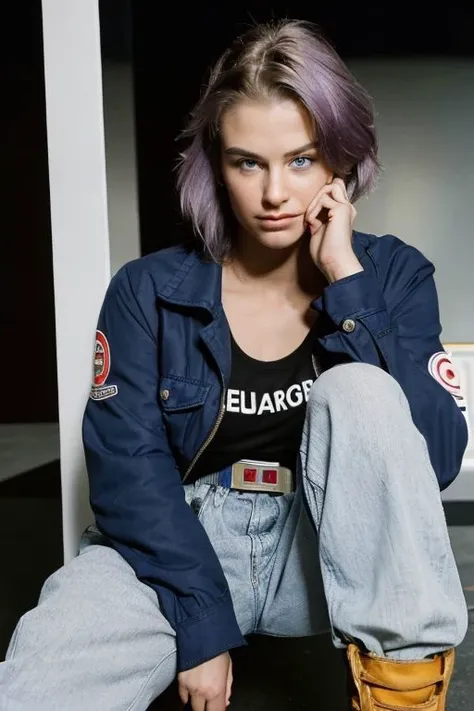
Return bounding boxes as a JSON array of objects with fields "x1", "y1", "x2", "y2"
[{"x1": 313, "y1": 236, "x2": 468, "y2": 489}]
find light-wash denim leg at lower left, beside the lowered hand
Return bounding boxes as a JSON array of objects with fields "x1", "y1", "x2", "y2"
[{"x1": 0, "y1": 532, "x2": 176, "y2": 711}]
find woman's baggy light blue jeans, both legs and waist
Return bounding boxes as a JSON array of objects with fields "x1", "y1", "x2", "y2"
[{"x1": 0, "y1": 364, "x2": 467, "y2": 711}]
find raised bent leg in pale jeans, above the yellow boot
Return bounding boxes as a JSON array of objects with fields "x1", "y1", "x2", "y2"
[{"x1": 301, "y1": 363, "x2": 467, "y2": 660}]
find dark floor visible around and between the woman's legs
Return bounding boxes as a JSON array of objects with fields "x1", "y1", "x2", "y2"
[{"x1": 0, "y1": 463, "x2": 474, "y2": 711}]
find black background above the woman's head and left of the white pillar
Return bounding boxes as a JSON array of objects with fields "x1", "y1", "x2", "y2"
[{"x1": 0, "y1": 0, "x2": 474, "y2": 423}]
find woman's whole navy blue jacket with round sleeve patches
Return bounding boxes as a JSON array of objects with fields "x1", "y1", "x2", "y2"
[{"x1": 83, "y1": 232, "x2": 467, "y2": 671}]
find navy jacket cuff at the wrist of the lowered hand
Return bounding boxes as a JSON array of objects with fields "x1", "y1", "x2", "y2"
[{"x1": 176, "y1": 593, "x2": 247, "y2": 672}]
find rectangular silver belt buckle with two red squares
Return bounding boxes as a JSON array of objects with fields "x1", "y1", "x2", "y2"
[{"x1": 231, "y1": 459, "x2": 294, "y2": 494}]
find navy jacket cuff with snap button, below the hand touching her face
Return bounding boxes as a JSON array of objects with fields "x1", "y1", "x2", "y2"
[{"x1": 312, "y1": 271, "x2": 386, "y2": 328}]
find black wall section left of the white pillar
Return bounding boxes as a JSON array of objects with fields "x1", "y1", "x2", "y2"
[{"x1": 0, "y1": 1, "x2": 57, "y2": 422}]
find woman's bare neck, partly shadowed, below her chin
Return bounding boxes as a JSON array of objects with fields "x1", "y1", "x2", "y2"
[{"x1": 227, "y1": 235, "x2": 327, "y2": 296}]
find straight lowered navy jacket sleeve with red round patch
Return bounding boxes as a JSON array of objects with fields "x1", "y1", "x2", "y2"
[{"x1": 83, "y1": 265, "x2": 246, "y2": 671}]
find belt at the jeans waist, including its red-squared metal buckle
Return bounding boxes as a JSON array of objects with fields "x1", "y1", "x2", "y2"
[{"x1": 198, "y1": 459, "x2": 295, "y2": 494}]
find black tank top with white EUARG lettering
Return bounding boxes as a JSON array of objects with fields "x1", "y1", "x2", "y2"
[{"x1": 189, "y1": 331, "x2": 316, "y2": 481}]
